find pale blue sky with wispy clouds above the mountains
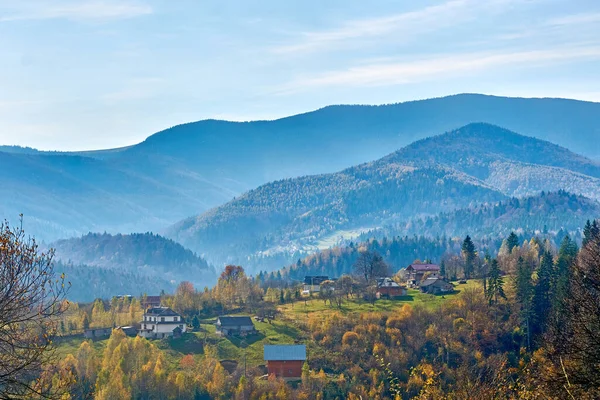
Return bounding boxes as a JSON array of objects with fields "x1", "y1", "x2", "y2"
[{"x1": 0, "y1": 0, "x2": 600, "y2": 150}]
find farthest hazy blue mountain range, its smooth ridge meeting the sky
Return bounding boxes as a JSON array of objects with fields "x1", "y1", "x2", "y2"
[{"x1": 0, "y1": 94, "x2": 600, "y2": 240}]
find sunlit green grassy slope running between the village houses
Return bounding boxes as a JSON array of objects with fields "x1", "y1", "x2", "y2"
[{"x1": 57, "y1": 280, "x2": 481, "y2": 367}]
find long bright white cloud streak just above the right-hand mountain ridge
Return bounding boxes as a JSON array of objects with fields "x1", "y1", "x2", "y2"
[{"x1": 275, "y1": 46, "x2": 600, "y2": 94}]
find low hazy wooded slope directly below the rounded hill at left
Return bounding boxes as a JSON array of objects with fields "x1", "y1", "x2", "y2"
[{"x1": 54, "y1": 261, "x2": 176, "y2": 302}]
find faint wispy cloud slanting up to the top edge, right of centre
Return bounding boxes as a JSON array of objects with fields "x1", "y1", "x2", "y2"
[{"x1": 272, "y1": 0, "x2": 515, "y2": 54}]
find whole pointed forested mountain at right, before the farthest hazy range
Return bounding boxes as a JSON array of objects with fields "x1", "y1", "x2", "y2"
[{"x1": 167, "y1": 123, "x2": 600, "y2": 265}]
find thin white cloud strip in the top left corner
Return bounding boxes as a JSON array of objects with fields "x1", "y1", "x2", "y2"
[{"x1": 0, "y1": 0, "x2": 153, "y2": 22}]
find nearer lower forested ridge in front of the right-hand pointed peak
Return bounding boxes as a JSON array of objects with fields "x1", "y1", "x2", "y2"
[{"x1": 168, "y1": 164, "x2": 504, "y2": 270}]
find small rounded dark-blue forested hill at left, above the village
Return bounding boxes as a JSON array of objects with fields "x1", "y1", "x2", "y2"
[{"x1": 50, "y1": 233, "x2": 216, "y2": 290}]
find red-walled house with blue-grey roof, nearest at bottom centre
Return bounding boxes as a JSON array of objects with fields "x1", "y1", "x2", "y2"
[{"x1": 264, "y1": 344, "x2": 306, "y2": 378}]
